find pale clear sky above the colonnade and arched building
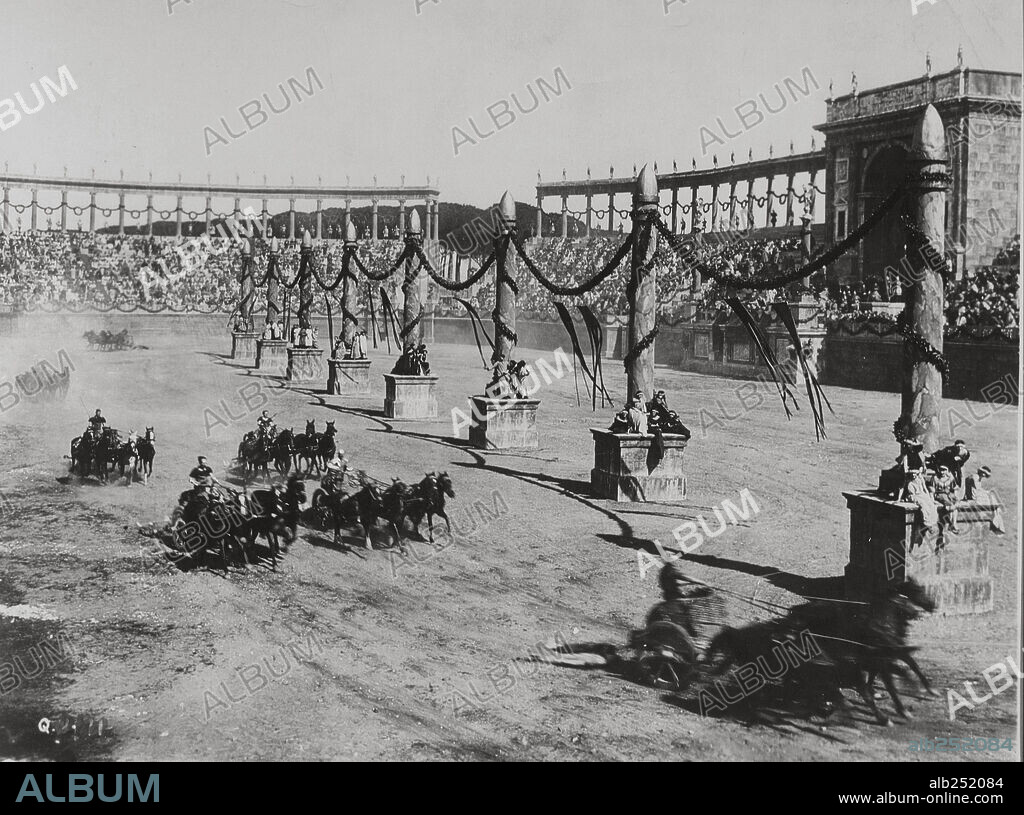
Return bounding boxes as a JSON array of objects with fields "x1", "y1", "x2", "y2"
[{"x1": 0, "y1": 0, "x2": 1022, "y2": 218}]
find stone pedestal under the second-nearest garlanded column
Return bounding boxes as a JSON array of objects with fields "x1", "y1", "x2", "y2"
[{"x1": 590, "y1": 428, "x2": 687, "y2": 502}]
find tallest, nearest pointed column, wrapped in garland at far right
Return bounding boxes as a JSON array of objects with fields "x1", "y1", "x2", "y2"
[{"x1": 901, "y1": 104, "x2": 949, "y2": 452}]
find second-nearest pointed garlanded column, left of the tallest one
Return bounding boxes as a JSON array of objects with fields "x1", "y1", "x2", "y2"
[{"x1": 626, "y1": 165, "x2": 657, "y2": 403}]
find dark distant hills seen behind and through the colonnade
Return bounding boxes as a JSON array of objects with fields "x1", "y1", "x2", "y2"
[{"x1": 97, "y1": 201, "x2": 607, "y2": 255}]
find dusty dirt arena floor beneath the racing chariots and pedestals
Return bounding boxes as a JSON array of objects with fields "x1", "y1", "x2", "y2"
[{"x1": 0, "y1": 325, "x2": 1020, "y2": 761}]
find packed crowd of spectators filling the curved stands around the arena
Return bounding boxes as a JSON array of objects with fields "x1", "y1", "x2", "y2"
[{"x1": 0, "y1": 231, "x2": 1020, "y2": 333}]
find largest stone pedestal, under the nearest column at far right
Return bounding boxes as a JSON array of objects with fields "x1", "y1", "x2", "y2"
[{"x1": 843, "y1": 491, "x2": 999, "y2": 614}]
